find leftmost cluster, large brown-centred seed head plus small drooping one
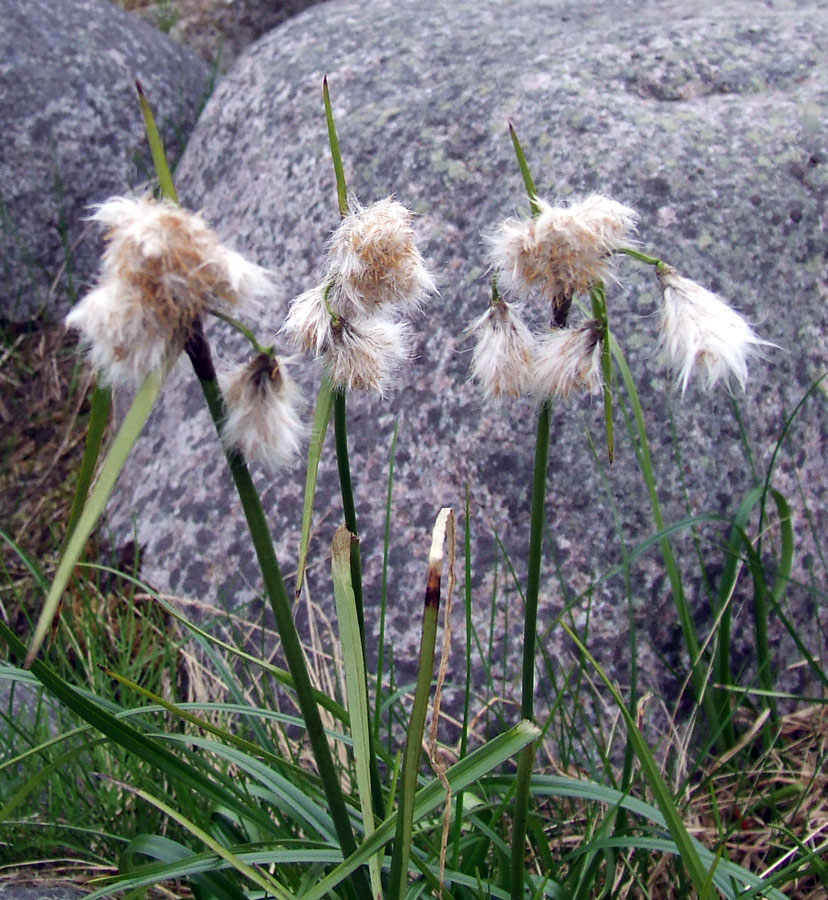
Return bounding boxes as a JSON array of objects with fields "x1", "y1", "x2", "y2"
[{"x1": 66, "y1": 197, "x2": 302, "y2": 465}]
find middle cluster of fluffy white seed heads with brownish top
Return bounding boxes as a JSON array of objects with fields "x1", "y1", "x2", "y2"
[{"x1": 282, "y1": 198, "x2": 436, "y2": 394}]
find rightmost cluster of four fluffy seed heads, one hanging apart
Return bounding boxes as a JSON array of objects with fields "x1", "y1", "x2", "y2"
[{"x1": 467, "y1": 194, "x2": 768, "y2": 401}]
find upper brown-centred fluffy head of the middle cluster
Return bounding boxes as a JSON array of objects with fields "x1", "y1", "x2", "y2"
[{"x1": 328, "y1": 197, "x2": 437, "y2": 318}]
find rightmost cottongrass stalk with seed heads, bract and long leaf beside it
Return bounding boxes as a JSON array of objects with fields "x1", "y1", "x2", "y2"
[{"x1": 468, "y1": 129, "x2": 784, "y2": 900}]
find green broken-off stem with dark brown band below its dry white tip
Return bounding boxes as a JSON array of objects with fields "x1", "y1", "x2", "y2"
[{"x1": 388, "y1": 556, "x2": 440, "y2": 900}]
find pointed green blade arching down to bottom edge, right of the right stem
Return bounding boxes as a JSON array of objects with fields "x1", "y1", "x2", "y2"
[{"x1": 560, "y1": 620, "x2": 709, "y2": 897}]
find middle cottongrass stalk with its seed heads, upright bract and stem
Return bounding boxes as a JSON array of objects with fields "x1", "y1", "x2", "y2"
[{"x1": 282, "y1": 79, "x2": 436, "y2": 818}]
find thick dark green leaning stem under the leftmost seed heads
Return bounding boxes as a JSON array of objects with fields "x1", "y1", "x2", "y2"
[{"x1": 186, "y1": 323, "x2": 371, "y2": 900}]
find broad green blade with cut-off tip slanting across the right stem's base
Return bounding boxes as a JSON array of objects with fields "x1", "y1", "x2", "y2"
[{"x1": 300, "y1": 720, "x2": 540, "y2": 900}]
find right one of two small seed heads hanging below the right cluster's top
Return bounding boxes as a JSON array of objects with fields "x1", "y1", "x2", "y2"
[{"x1": 532, "y1": 319, "x2": 603, "y2": 399}]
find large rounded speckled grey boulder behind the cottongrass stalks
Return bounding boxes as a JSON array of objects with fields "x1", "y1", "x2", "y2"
[{"x1": 106, "y1": 0, "x2": 828, "y2": 732}]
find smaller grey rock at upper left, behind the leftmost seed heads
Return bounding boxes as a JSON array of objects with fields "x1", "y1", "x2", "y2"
[{"x1": 0, "y1": 0, "x2": 209, "y2": 321}]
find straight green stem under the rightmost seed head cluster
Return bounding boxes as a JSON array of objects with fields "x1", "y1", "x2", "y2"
[{"x1": 511, "y1": 400, "x2": 551, "y2": 900}]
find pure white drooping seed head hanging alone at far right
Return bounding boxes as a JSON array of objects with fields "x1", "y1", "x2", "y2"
[{"x1": 658, "y1": 266, "x2": 772, "y2": 393}]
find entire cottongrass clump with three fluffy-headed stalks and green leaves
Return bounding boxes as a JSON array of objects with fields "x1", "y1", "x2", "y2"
[{"x1": 8, "y1": 84, "x2": 828, "y2": 900}]
